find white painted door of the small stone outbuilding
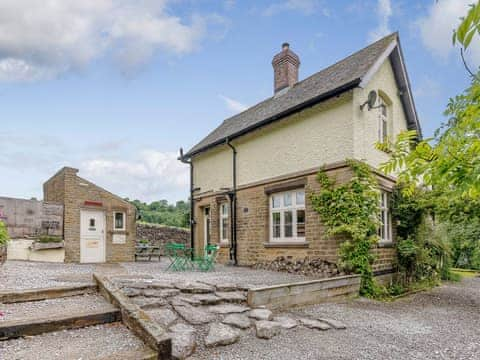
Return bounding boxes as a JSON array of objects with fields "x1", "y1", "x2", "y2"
[{"x1": 80, "y1": 210, "x2": 105, "y2": 263}]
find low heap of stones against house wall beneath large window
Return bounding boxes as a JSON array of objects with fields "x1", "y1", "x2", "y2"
[{"x1": 253, "y1": 256, "x2": 346, "y2": 278}]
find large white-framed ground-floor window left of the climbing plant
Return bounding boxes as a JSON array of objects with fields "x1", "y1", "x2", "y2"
[{"x1": 270, "y1": 190, "x2": 305, "y2": 242}]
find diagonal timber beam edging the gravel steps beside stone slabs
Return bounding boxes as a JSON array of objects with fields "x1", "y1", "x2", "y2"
[{"x1": 93, "y1": 273, "x2": 172, "y2": 359}]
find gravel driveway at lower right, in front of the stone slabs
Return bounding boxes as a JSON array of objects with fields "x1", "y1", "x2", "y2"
[{"x1": 192, "y1": 278, "x2": 480, "y2": 360}]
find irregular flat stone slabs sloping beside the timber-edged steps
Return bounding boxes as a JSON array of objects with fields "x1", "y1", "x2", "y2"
[{"x1": 116, "y1": 279, "x2": 345, "y2": 359}]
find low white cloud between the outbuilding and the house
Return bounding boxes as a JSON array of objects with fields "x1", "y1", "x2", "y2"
[{"x1": 79, "y1": 150, "x2": 189, "y2": 202}]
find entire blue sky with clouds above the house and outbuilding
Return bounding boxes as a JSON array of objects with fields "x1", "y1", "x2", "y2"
[{"x1": 0, "y1": 0, "x2": 480, "y2": 202}]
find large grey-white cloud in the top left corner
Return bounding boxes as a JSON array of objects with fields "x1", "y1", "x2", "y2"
[{"x1": 0, "y1": 0, "x2": 216, "y2": 81}]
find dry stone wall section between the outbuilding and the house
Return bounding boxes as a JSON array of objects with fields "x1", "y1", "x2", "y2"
[{"x1": 137, "y1": 223, "x2": 190, "y2": 251}]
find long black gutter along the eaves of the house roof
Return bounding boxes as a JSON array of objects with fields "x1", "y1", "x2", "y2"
[{"x1": 185, "y1": 78, "x2": 362, "y2": 159}]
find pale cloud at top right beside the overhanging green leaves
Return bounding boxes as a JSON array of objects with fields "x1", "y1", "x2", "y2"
[{"x1": 416, "y1": 0, "x2": 480, "y2": 65}]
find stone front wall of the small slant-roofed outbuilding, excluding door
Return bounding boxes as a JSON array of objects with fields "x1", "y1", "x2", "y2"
[{"x1": 43, "y1": 168, "x2": 136, "y2": 262}]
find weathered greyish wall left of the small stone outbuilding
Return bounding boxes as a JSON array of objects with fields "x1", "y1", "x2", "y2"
[{"x1": 0, "y1": 197, "x2": 63, "y2": 239}]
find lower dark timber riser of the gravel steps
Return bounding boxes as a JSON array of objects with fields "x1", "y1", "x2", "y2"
[{"x1": 0, "y1": 309, "x2": 121, "y2": 340}]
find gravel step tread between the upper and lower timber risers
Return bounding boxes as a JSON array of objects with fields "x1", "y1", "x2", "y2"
[{"x1": 0, "y1": 295, "x2": 115, "y2": 324}]
